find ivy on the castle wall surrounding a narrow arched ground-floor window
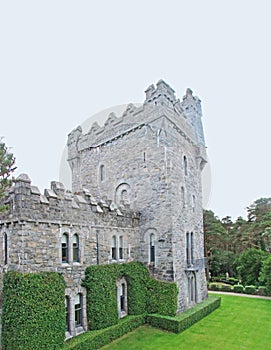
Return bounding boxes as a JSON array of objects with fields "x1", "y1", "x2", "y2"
[{"x1": 84, "y1": 262, "x2": 178, "y2": 330}]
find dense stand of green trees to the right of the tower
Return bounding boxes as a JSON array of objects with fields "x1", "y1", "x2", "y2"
[{"x1": 203, "y1": 198, "x2": 271, "y2": 285}]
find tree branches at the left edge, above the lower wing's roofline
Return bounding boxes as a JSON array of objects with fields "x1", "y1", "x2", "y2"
[{"x1": 0, "y1": 139, "x2": 16, "y2": 212}]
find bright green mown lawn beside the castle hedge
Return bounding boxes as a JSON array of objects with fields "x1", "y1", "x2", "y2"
[{"x1": 102, "y1": 295, "x2": 271, "y2": 350}]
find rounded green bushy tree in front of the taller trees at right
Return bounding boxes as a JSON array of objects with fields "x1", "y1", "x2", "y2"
[{"x1": 236, "y1": 248, "x2": 268, "y2": 286}]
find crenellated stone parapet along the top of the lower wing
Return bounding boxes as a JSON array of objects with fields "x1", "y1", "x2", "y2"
[{"x1": 1, "y1": 174, "x2": 139, "y2": 226}]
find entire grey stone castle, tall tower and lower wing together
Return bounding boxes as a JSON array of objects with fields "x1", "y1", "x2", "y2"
[{"x1": 0, "y1": 80, "x2": 207, "y2": 338}]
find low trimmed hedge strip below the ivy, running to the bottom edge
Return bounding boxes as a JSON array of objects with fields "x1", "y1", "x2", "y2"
[{"x1": 65, "y1": 315, "x2": 146, "y2": 350}]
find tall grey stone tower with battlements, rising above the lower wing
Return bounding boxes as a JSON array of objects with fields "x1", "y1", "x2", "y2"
[{"x1": 68, "y1": 80, "x2": 207, "y2": 311}]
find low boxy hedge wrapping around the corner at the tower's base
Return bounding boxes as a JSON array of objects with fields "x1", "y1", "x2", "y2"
[{"x1": 146, "y1": 296, "x2": 221, "y2": 333}]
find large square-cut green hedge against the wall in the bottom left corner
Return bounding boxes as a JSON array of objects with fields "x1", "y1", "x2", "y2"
[{"x1": 2, "y1": 271, "x2": 66, "y2": 350}]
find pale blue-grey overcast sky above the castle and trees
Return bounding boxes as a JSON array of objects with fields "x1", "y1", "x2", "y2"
[{"x1": 0, "y1": 0, "x2": 271, "y2": 219}]
